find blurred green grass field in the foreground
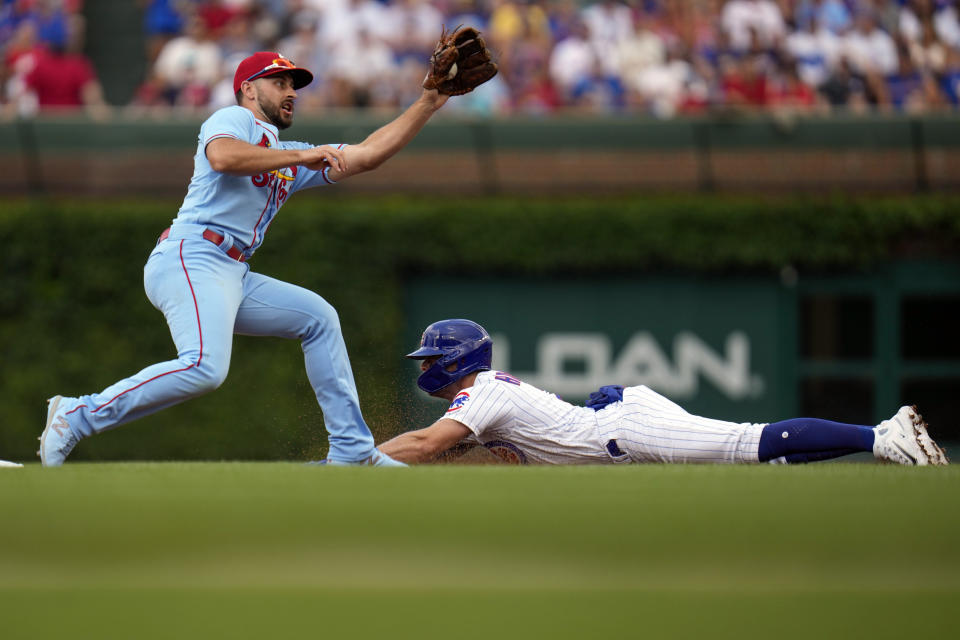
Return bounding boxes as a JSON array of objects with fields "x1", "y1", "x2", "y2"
[{"x1": 0, "y1": 463, "x2": 960, "y2": 640}]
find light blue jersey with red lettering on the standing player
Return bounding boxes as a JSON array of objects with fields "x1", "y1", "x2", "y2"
[{"x1": 174, "y1": 106, "x2": 344, "y2": 258}]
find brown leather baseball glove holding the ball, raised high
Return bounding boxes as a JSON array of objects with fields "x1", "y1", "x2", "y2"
[{"x1": 423, "y1": 27, "x2": 497, "y2": 96}]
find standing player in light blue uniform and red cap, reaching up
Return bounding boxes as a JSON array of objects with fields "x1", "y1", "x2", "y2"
[{"x1": 39, "y1": 28, "x2": 497, "y2": 467}]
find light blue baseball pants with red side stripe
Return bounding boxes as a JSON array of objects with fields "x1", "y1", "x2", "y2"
[{"x1": 67, "y1": 224, "x2": 374, "y2": 462}]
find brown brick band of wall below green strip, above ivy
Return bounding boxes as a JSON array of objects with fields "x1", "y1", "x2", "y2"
[{"x1": 0, "y1": 149, "x2": 960, "y2": 197}]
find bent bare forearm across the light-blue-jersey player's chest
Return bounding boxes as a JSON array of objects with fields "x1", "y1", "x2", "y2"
[{"x1": 206, "y1": 138, "x2": 347, "y2": 176}]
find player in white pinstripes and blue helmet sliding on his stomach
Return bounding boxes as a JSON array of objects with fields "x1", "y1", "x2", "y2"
[{"x1": 379, "y1": 320, "x2": 948, "y2": 465}]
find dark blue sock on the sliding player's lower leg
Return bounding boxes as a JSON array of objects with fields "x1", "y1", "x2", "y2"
[{"x1": 758, "y1": 418, "x2": 874, "y2": 464}]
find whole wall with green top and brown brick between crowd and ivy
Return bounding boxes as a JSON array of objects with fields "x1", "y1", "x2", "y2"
[{"x1": 0, "y1": 114, "x2": 960, "y2": 197}]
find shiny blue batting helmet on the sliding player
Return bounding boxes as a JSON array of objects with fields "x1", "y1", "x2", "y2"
[{"x1": 407, "y1": 319, "x2": 493, "y2": 393}]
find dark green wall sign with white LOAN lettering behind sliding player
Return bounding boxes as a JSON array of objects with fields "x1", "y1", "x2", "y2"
[{"x1": 405, "y1": 277, "x2": 794, "y2": 422}]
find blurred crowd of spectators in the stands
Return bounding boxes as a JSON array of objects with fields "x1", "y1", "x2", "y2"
[{"x1": 0, "y1": 0, "x2": 960, "y2": 118}]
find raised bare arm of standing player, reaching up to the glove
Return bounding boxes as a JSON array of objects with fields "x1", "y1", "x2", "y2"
[{"x1": 327, "y1": 89, "x2": 449, "y2": 182}]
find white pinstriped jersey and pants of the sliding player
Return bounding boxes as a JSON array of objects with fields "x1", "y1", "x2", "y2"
[{"x1": 444, "y1": 371, "x2": 765, "y2": 464}]
